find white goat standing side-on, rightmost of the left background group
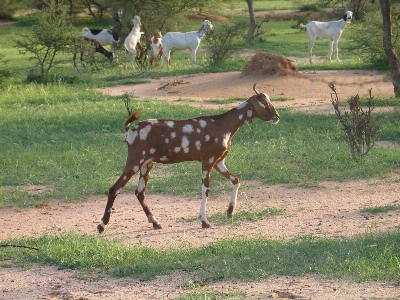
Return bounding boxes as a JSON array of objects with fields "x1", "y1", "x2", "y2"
[{"x1": 160, "y1": 20, "x2": 214, "y2": 68}]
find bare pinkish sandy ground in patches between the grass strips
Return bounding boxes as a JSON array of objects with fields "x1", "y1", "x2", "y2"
[{"x1": 0, "y1": 71, "x2": 400, "y2": 299}]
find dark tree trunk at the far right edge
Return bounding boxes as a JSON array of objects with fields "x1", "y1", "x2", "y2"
[{"x1": 379, "y1": 0, "x2": 400, "y2": 98}]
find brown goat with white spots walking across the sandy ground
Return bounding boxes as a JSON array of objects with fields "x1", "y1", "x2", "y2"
[{"x1": 97, "y1": 84, "x2": 279, "y2": 233}]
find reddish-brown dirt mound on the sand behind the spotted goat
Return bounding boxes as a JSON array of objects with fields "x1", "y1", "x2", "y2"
[{"x1": 242, "y1": 52, "x2": 298, "y2": 77}]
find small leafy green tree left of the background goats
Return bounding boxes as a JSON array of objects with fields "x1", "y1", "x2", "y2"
[{"x1": 15, "y1": 0, "x2": 74, "y2": 79}]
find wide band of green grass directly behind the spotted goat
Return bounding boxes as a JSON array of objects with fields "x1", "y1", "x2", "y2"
[{"x1": 0, "y1": 84, "x2": 400, "y2": 207}]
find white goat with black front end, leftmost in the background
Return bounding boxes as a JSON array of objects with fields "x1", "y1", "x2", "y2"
[{"x1": 82, "y1": 9, "x2": 122, "y2": 58}]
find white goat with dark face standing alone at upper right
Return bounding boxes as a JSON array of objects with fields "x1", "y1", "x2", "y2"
[{"x1": 300, "y1": 11, "x2": 353, "y2": 63}]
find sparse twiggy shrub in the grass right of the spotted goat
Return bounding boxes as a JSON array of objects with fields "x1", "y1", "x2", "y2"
[{"x1": 329, "y1": 84, "x2": 382, "y2": 159}]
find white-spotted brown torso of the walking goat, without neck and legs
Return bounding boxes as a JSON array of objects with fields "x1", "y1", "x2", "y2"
[{"x1": 125, "y1": 117, "x2": 230, "y2": 164}]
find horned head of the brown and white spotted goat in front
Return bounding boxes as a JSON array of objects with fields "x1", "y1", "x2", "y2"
[{"x1": 248, "y1": 83, "x2": 279, "y2": 124}]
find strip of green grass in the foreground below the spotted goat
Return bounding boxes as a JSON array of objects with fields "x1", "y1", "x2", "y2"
[{"x1": 0, "y1": 232, "x2": 400, "y2": 285}]
